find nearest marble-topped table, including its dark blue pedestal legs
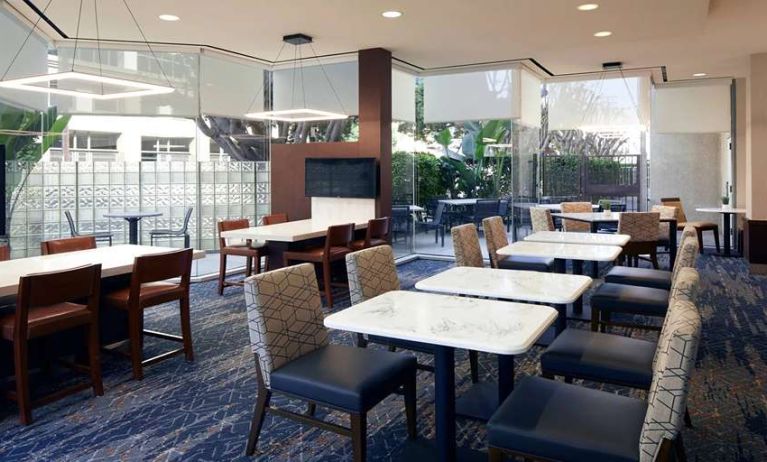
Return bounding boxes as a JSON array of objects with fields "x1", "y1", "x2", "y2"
[{"x1": 325, "y1": 291, "x2": 557, "y2": 462}]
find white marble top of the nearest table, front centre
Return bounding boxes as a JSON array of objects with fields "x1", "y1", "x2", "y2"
[{"x1": 325, "y1": 290, "x2": 557, "y2": 355}]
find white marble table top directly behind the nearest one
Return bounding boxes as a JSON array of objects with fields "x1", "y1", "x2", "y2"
[{"x1": 415, "y1": 266, "x2": 591, "y2": 304}]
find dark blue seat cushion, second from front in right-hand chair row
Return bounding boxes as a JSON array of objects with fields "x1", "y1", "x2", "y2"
[{"x1": 541, "y1": 329, "x2": 657, "y2": 389}]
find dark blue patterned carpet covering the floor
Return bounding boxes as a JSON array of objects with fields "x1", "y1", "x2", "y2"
[{"x1": 0, "y1": 256, "x2": 767, "y2": 462}]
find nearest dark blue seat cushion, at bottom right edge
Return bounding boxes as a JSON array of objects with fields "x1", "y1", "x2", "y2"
[{"x1": 487, "y1": 377, "x2": 647, "y2": 462}]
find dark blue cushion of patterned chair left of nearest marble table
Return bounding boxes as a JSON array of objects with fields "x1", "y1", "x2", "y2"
[{"x1": 271, "y1": 345, "x2": 416, "y2": 412}]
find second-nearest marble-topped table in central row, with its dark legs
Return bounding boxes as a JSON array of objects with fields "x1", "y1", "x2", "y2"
[{"x1": 415, "y1": 266, "x2": 592, "y2": 420}]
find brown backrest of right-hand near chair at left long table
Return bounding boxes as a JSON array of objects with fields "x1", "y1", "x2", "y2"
[{"x1": 130, "y1": 249, "x2": 192, "y2": 300}]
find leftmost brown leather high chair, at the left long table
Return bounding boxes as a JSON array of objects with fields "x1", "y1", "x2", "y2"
[{"x1": 0, "y1": 265, "x2": 104, "y2": 425}]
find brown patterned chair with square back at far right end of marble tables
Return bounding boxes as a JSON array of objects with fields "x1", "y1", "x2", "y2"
[{"x1": 618, "y1": 212, "x2": 660, "y2": 269}]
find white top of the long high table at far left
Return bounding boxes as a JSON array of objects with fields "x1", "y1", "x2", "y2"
[{"x1": 0, "y1": 244, "x2": 205, "y2": 296}]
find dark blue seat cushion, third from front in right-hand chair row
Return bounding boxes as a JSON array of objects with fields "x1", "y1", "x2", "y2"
[{"x1": 591, "y1": 282, "x2": 669, "y2": 316}]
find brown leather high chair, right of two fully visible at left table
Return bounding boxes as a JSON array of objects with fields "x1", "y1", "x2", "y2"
[{"x1": 104, "y1": 249, "x2": 194, "y2": 380}]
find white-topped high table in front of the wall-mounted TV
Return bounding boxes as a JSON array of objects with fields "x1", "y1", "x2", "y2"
[{"x1": 221, "y1": 218, "x2": 368, "y2": 270}]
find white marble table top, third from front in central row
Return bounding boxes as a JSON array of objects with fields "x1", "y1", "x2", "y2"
[{"x1": 498, "y1": 241, "x2": 623, "y2": 261}]
